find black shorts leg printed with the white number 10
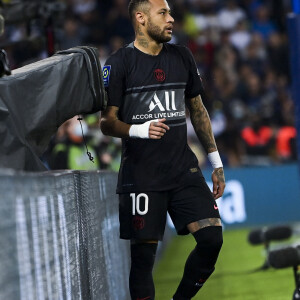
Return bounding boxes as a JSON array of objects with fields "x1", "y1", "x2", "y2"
[{"x1": 119, "y1": 192, "x2": 168, "y2": 240}]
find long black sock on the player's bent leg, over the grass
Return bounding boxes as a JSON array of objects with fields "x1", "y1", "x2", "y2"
[{"x1": 173, "y1": 226, "x2": 223, "y2": 300}]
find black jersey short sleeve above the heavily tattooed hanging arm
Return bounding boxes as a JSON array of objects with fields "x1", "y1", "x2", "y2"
[{"x1": 184, "y1": 47, "x2": 203, "y2": 98}]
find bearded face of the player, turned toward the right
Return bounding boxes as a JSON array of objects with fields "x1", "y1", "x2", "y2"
[{"x1": 147, "y1": 0, "x2": 174, "y2": 43}]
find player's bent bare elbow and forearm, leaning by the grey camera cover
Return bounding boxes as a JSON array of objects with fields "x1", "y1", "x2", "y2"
[{"x1": 100, "y1": 106, "x2": 130, "y2": 138}]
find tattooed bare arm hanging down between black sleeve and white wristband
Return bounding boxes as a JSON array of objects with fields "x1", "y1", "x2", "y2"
[{"x1": 187, "y1": 96, "x2": 217, "y2": 153}]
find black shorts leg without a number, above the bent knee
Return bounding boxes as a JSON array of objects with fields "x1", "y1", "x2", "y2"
[{"x1": 168, "y1": 177, "x2": 220, "y2": 234}]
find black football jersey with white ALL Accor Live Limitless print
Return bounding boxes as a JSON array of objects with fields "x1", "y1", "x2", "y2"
[{"x1": 103, "y1": 43, "x2": 202, "y2": 193}]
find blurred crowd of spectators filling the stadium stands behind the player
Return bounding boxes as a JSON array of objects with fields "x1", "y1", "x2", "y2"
[{"x1": 0, "y1": 0, "x2": 297, "y2": 171}]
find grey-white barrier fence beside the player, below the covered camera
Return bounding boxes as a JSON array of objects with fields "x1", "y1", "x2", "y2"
[{"x1": 0, "y1": 169, "x2": 129, "y2": 300}]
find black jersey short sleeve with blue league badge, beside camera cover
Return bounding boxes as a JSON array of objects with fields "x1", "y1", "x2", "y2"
[{"x1": 103, "y1": 51, "x2": 125, "y2": 107}]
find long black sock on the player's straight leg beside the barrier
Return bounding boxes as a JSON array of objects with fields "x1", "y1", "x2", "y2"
[{"x1": 129, "y1": 243, "x2": 157, "y2": 300}]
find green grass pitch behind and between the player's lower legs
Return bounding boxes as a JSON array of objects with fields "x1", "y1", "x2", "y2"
[{"x1": 154, "y1": 229, "x2": 295, "y2": 300}]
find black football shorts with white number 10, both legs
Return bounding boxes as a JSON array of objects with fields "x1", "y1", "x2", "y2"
[{"x1": 119, "y1": 172, "x2": 220, "y2": 240}]
